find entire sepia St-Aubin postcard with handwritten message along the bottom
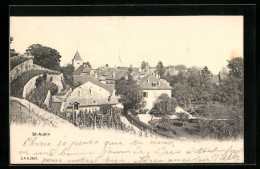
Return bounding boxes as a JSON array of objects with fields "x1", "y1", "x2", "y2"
[{"x1": 9, "y1": 15, "x2": 244, "y2": 164}]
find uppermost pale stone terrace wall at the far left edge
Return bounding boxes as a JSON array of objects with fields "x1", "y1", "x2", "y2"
[{"x1": 10, "y1": 59, "x2": 33, "y2": 81}]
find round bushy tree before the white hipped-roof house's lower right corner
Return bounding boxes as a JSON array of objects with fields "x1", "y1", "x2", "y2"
[{"x1": 150, "y1": 94, "x2": 177, "y2": 116}]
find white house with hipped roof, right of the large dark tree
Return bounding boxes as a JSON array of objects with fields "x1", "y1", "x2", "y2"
[{"x1": 139, "y1": 74, "x2": 172, "y2": 110}]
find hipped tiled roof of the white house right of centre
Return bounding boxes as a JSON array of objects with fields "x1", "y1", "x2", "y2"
[{"x1": 140, "y1": 75, "x2": 172, "y2": 90}]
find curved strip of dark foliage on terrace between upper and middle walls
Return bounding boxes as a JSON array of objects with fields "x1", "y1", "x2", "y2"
[{"x1": 10, "y1": 70, "x2": 58, "y2": 98}]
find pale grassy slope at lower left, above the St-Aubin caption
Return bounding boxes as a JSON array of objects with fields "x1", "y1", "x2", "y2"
[{"x1": 9, "y1": 101, "x2": 52, "y2": 126}]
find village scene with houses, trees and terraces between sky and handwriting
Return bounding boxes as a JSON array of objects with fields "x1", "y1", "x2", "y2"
[{"x1": 10, "y1": 37, "x2": 244, "y2": 139}]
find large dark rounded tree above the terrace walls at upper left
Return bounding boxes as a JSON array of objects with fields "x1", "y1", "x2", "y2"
[{"x1": 26, "y1": 44, "x2": 61, "y2": 70}]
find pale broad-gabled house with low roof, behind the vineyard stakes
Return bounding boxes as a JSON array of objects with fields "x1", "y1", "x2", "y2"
[{"x1": 67, "y1": 75, "x2": 118, "y2": 111}]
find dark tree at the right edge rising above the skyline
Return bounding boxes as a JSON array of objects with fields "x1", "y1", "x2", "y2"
[{"x1": 227, "y1": 57, "x2": 244, "y2": 79}]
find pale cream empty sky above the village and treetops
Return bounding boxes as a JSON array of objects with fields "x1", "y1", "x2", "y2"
[{"x1": 10, "y1": 16, "x2": 243, "y2": 74}]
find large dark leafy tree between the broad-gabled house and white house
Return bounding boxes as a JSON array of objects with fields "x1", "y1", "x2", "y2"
[{"x1": 115, "y1": 79, "x2": 143, "y2": 110}]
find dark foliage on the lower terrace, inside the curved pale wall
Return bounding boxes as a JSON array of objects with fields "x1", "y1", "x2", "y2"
[{"x1": 28, "y1": 82, "x2": 58, "y2": 107}]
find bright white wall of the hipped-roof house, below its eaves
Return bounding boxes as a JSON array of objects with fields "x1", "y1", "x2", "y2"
[{"x1": 142, "y1": 90, "x2": 172, "y2": 110}]
